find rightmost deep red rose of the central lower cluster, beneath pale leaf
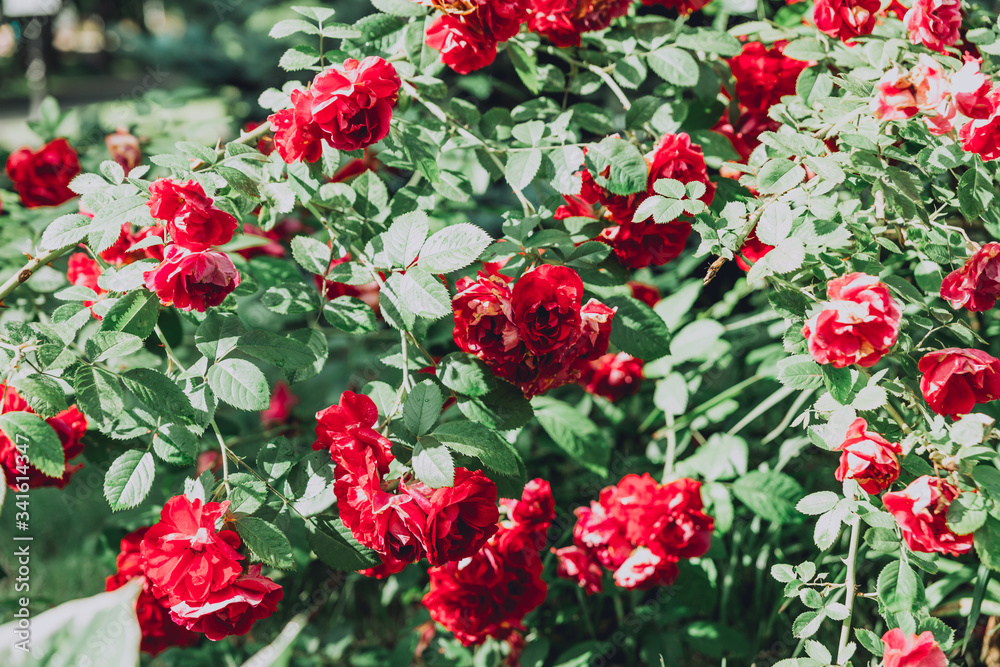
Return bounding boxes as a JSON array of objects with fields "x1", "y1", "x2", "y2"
[{"x1": 400, "y1": 468, "x2": 500, "y2": 565}]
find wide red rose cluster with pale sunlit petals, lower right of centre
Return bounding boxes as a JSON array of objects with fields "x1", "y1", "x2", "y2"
[{"x1": 553, "y1": 473, "x2": 715, "y2": 593}]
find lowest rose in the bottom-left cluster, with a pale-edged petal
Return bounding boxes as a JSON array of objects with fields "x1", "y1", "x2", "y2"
[{"x1": 170, "y1": 565, "x2": 284, "y2": 641}]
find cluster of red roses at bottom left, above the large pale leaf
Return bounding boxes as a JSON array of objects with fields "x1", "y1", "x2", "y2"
[{"x1": 114, "y1": 496, "x2": 282, "y2": 640}]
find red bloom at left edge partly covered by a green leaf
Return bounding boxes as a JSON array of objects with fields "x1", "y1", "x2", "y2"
[{"x1": 0, "y1": 383, "x2": 87, "y2": 491}]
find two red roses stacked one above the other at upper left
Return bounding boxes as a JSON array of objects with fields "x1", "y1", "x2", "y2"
[{"x1": 143, "y1": 178, "x2": 240, "y2": 313}]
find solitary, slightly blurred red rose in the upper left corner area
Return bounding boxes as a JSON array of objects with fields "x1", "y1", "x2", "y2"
[{"x1": 7, "y1": 139, "x2": 80, "y2": 208}]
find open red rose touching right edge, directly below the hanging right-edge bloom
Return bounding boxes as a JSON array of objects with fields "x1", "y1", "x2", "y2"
[{"x1": 917, "y1": 347, "x2": 1000, "y2": 419}]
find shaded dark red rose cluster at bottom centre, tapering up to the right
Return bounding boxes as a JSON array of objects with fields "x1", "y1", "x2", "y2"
[{"x1": 424, "y1": 479, "x2": 555, "y2": 652}]
